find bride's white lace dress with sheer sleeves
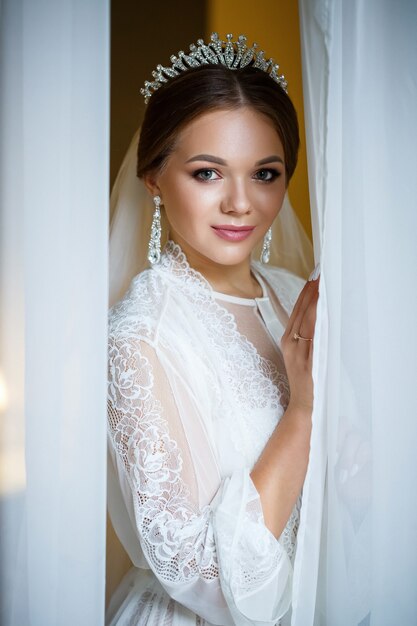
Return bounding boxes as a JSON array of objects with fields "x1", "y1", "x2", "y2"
[{"x1": 106, "y1": 242, "x2": 304, "y2": 626}]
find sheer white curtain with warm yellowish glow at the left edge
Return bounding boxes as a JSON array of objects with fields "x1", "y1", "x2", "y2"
[{"x1": 0, "y1": 0, "x2": 109, "y2": 626}]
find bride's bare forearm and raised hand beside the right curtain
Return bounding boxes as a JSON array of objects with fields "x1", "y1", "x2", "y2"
[{"x1": 251, "y1": 280, "x2": 319, "y2": 537}]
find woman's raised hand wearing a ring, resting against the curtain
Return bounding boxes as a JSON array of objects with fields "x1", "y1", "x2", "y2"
[{"x1": 281, "y1": 278, "x2": 320, "y2": 414}]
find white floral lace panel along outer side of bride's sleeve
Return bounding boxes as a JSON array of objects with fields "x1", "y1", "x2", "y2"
[{"x1": 108, "y1": 336, "x2": 218, "y2": 582}]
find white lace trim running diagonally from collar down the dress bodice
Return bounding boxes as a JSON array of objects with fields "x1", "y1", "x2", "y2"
[{"x1": 154, "y1": 241, "x2": 290, "y2": 467}]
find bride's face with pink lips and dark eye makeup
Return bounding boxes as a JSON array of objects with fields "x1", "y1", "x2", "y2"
[{"x1": 145, "y1": 107, "x2": 286, "y2": 266}]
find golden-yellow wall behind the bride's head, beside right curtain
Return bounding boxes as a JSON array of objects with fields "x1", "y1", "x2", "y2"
[{"x1": 206, "y1": 0, "x2": 311, "y2": 238}]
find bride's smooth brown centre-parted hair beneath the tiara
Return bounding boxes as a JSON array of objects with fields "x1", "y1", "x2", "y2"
[{"x1": 137, "y1": 65, "x2": 300, "y2": 184}]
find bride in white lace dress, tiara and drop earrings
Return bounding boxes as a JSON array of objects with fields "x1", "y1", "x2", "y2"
[{"x1": 106, "y1": 35, "x2": 319, "y2": 626}]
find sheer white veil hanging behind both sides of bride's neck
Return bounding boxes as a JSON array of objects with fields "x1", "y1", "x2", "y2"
[{"x1": 109, "y1": 129, "x2": 314, "y2": 306}]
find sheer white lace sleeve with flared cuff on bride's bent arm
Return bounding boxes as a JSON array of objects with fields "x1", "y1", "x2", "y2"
[{"x1": 108, "y1": 335, "x2": 292, "y2": 625}]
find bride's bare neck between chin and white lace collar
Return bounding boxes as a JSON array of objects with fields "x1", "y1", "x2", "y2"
[{"x1": 167, "y1": 237, "x2": 262, "y2": 298}]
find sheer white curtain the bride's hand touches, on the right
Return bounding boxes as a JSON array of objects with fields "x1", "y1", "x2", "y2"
[{"x1": 292, "y1": 0, "x2": 417, "y2": 626}]
